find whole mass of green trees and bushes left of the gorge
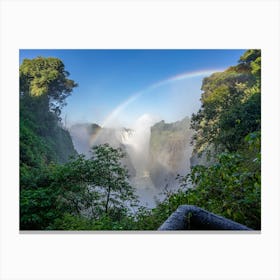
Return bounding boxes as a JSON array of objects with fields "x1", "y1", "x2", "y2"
[{"x1": 20, "y1": 57, "x2": 141, "y2": 230}]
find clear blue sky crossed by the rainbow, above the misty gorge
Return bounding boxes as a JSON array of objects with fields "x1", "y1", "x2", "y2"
[{"x1": 20, "y1": 50, "x2": 245, "y2": 127}]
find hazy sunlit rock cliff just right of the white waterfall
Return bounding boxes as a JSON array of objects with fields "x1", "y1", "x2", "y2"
[{"x1": 149, "y1": 117, "x2": 192, "y2": 188}]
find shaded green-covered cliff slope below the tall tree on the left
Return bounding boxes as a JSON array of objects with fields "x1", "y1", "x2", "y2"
[{"x1": 20, "y1": 103, "x2": 77, "y2": 167}]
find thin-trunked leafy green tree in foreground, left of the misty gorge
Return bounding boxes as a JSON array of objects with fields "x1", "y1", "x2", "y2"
[{"x1": 51, "y1": 144, "x2": 138, "y2": 225}]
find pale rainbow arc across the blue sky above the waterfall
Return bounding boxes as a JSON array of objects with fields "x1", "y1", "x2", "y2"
[{"x1": 101, "y1": 69, "x2": 224, "y2": 127}]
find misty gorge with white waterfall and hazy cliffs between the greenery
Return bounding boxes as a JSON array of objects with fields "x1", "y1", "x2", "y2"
[{"x1": 69, "y1": 114, "x2": 192, "y2": 208}]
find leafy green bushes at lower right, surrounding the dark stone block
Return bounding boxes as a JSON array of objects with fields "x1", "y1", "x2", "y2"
[{"x1": 135, "y1": 132, "x2": 261, "y2": 230}]
